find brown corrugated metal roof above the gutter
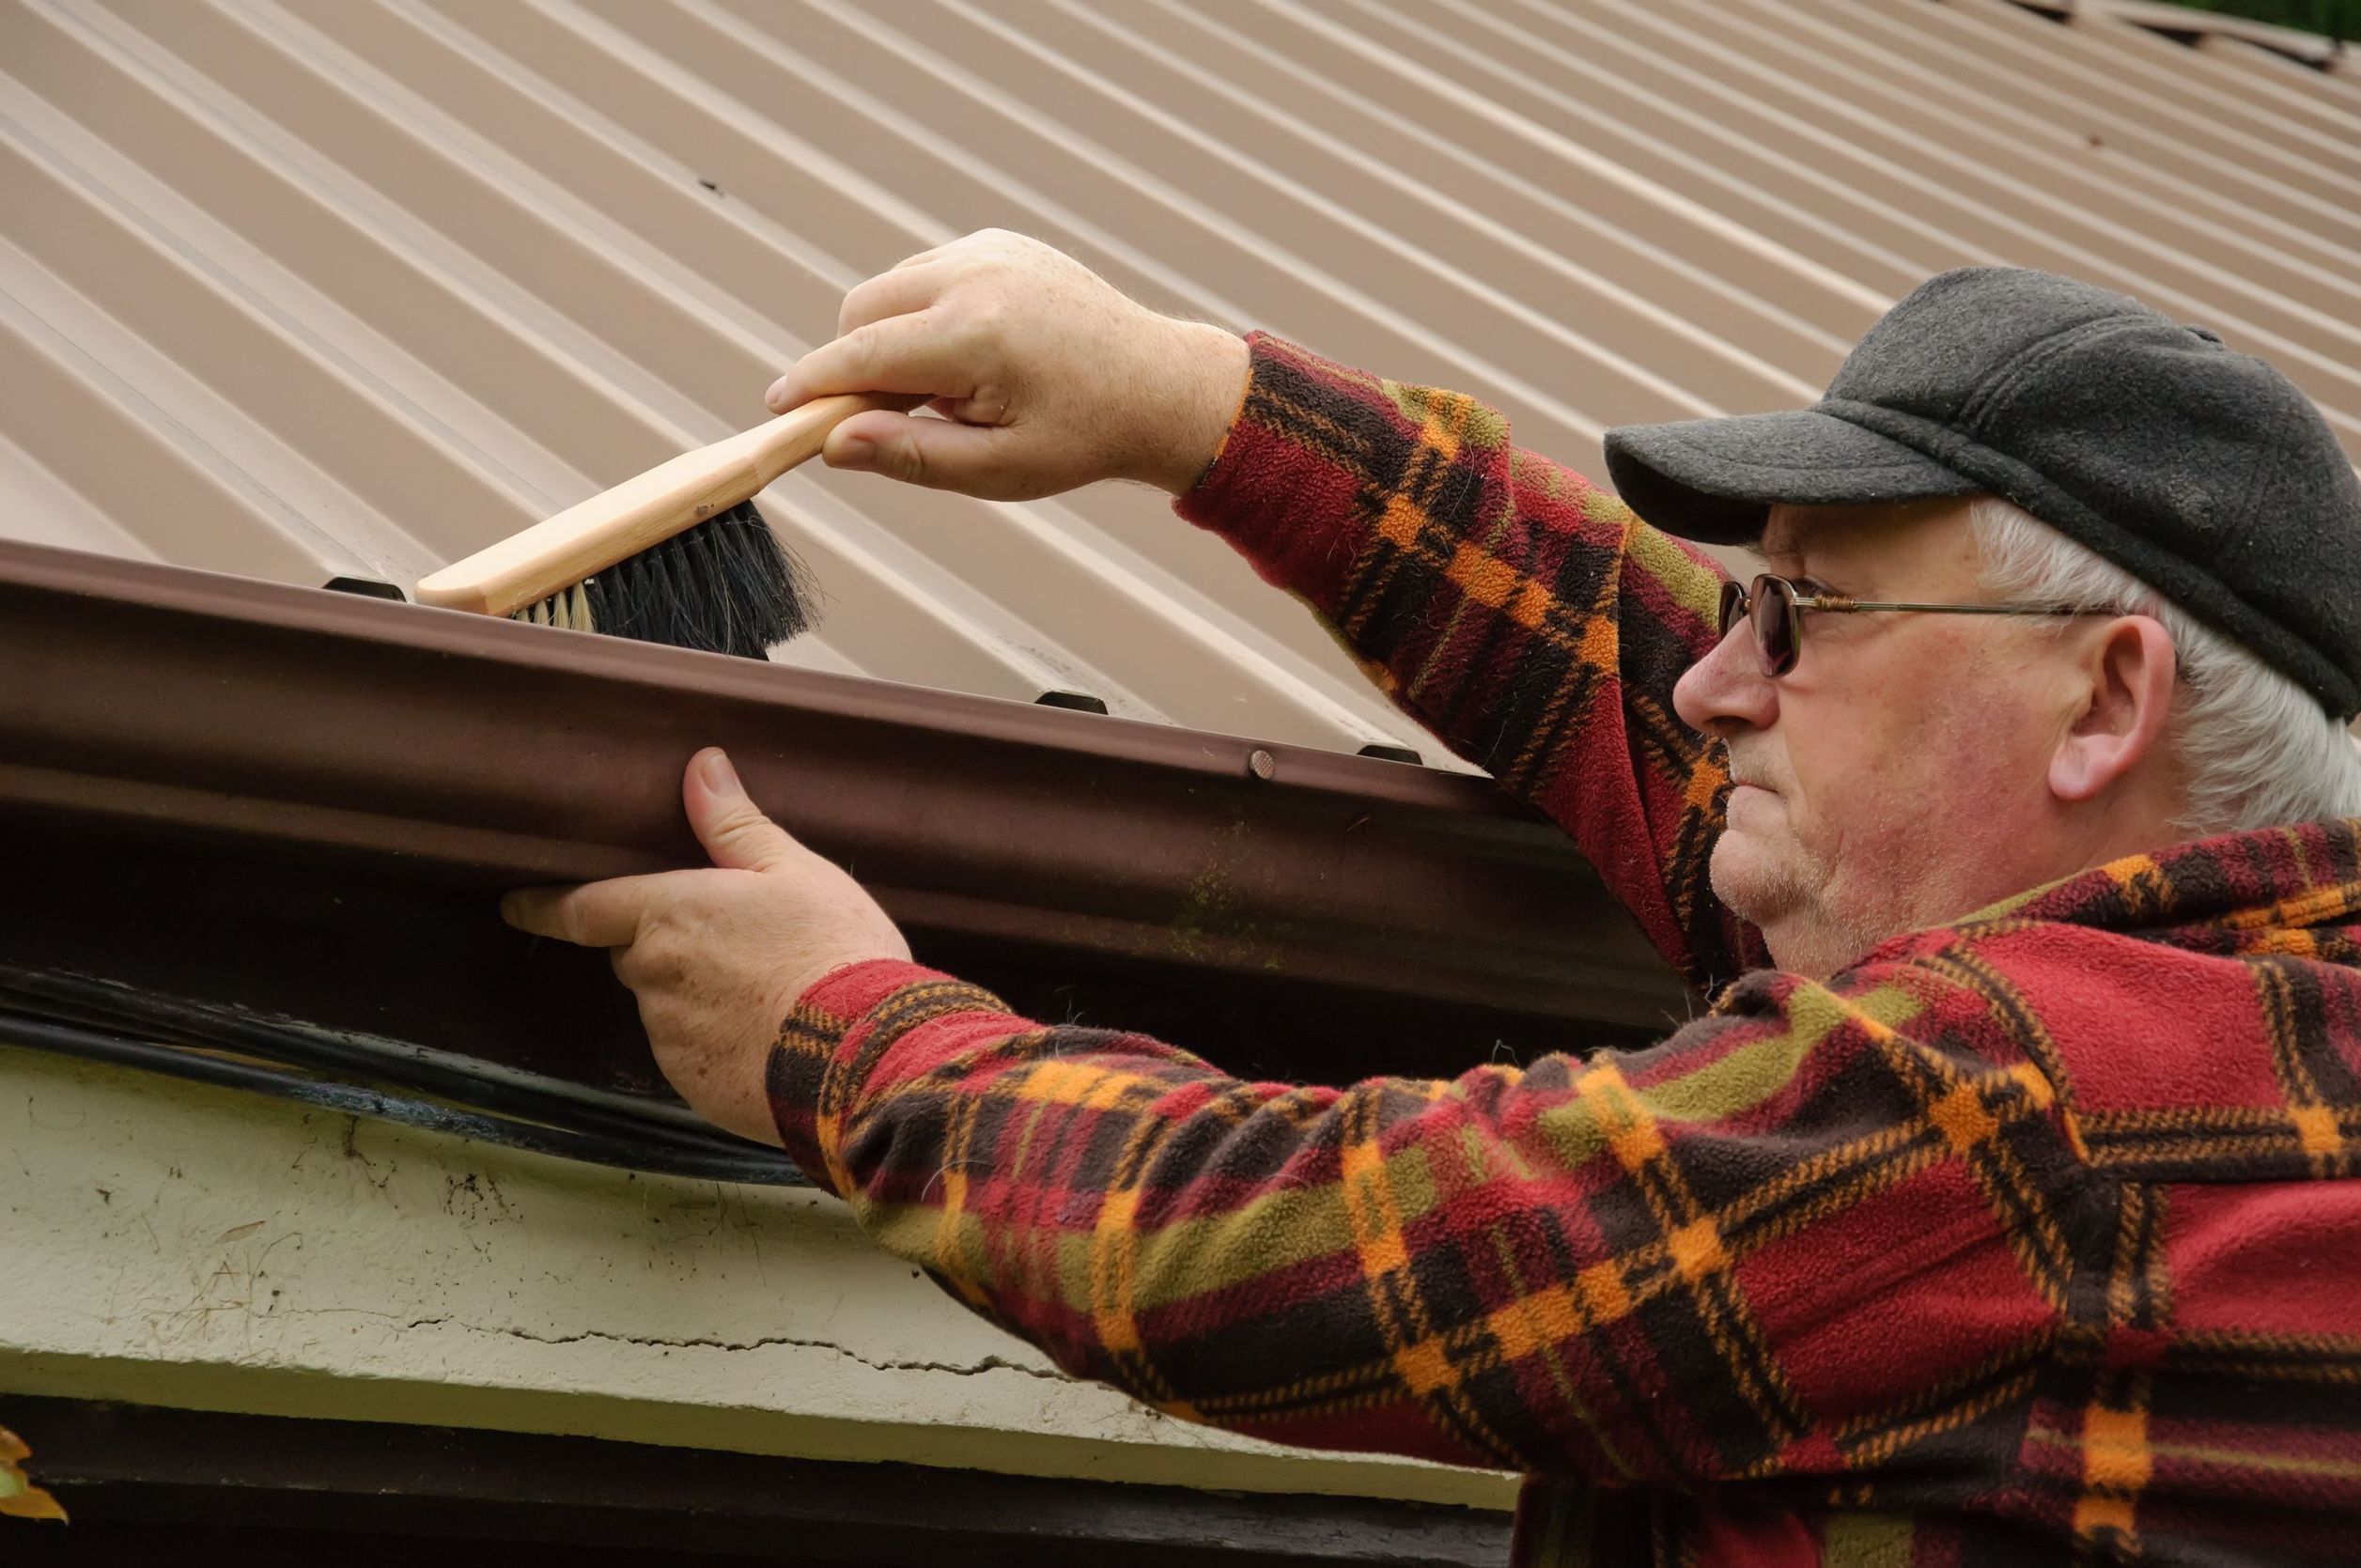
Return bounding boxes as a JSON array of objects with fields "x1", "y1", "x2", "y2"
[{"x1": 0, "y1": 0, "x2": 2361, "y2": 755}]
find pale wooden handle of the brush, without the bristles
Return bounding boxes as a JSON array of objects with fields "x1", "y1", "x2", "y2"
[{"x1": 418, "y1": 392, "x2": 887, "y2": 616}]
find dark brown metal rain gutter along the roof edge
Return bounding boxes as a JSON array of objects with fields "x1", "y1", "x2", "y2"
[{"x1": 0, "y1": 543, "x2": 1681, "y2": 1067}]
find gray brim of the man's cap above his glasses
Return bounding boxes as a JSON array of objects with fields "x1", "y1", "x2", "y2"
[{"x1": 1606, "y1": 409, "x2": 1985, "y2": 546}]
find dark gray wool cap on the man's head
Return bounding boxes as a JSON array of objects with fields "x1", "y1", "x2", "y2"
[{"x1": 1606, "y1": 267, "x2": 2361, "y2": 718}]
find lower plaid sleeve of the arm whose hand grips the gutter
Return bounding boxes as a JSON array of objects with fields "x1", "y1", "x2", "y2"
[{"x1": 769, "y1": 961, "x2": 2071, "y2": 1499}]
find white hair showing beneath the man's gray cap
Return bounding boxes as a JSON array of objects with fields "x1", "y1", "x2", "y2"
[{"x1": 1966, "y1": 496, "x2": 2361, "y2": 836}]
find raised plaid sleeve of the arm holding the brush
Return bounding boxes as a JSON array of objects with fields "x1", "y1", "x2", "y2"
[{"x1": 1178, "y1": 333, "x2": 1763, "y2": 989}]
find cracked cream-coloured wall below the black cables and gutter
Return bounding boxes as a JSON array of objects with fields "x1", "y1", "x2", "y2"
[{"x1": 0, "y1": 1048, "x2": 1511, "y2": 1507}]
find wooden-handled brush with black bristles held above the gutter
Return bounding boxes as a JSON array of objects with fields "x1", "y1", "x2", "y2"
[{"x1": 418, "y1": 395, "x2": 887, "y2": 659}]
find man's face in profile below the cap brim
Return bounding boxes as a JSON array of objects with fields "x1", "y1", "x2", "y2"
[{"x1": 1674, "y1": 501, "x2": 2071, "y2": 975}]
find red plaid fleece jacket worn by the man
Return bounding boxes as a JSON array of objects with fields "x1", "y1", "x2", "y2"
[{"x1": 772, "y1": 337, "x2": 2361, "y2": 1565}]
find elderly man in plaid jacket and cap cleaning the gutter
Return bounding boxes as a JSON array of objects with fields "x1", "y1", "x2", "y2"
[{"x1": 507, "y1": 234, "x2": 2361, "y2": 1563}]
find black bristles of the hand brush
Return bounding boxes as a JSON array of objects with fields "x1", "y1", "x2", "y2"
[{"x1": 512, "y1": 501, "x2": 812, "y2": 659}]
